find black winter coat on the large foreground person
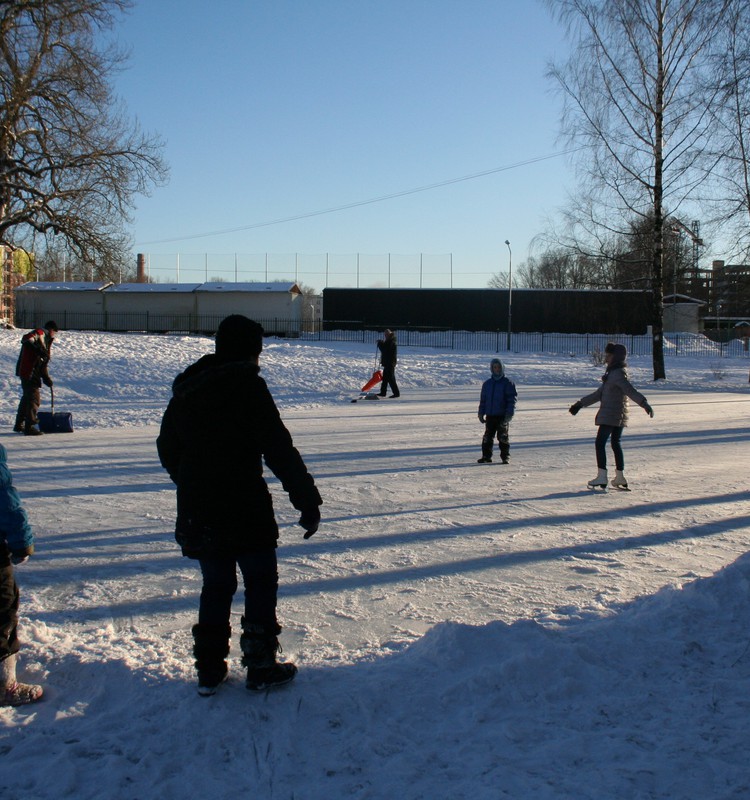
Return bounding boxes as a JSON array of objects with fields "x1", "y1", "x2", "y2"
[{"x1": 156, "y1": 355, "x2": 322, "y2": 558}]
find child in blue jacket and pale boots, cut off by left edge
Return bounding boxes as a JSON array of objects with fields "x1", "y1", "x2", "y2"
[{"x1": 0, "y1": 444, "x2": 43, "y2": 706}]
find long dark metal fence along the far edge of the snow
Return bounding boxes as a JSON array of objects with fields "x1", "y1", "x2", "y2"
[{"x1": 16, "y1": 312, "x2": 750, "y2": 358}]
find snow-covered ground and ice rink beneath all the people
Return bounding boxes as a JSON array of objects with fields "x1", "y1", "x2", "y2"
[{"x1": 0, "y1": 330, "x2": 750, "y2": 800}]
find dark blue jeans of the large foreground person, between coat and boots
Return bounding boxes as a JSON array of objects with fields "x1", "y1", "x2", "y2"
[{"x1": 198, "y1": 549, "x2": 279, "y2": 629}]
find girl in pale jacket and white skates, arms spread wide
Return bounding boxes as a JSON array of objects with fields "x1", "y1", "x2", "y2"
[{"x1": 568, "y1": 342, "x2": 654, "y2": 490}]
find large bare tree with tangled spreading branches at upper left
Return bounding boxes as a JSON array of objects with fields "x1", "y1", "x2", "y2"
[{"x1": 0, "y1": 0, "x2": 166, "y2": 277}]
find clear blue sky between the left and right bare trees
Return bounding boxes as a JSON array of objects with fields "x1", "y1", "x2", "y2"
[{"x1": 117, "y1": 0, "x2": 574, "y2": 288}]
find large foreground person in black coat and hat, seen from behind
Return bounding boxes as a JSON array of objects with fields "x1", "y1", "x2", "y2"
[{"x1": 156, "y1": 314, "x2": 322, "y2": 695}]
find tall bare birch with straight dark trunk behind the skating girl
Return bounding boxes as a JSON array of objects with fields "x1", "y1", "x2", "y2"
[{"x1": 547, "y1": 0, "x2": 729, "y2": 380}]
